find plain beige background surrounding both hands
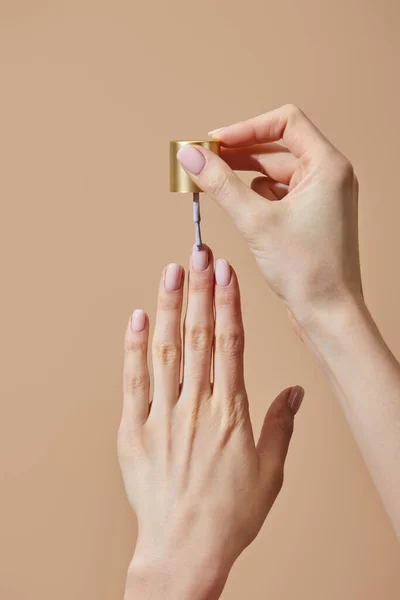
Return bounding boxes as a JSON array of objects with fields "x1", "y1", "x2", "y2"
[{"x1": 0, "y1": 0, "x2": 400, "y2": 600}]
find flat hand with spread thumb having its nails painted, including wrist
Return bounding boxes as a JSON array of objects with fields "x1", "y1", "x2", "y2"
[{"x1": 118, "y1": 249, "x2": 304, "y2": 600}]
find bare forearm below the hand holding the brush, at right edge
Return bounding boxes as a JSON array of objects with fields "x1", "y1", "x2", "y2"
[{"x1": 304, "y1": 300, "x2": 400, "y2": 537}]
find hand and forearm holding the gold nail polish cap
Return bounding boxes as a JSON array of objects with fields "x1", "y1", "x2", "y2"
[{"x1": 178, "y1": 106, "x2": 400, "y2": 537}]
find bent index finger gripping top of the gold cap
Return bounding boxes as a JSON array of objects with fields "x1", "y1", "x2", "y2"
[{"x1": 209, "y1": 104, "x2": 331, "y2": 158}]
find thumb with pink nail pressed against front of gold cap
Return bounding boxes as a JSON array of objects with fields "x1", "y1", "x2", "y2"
[{"x1": 177, "y1": 144, "x2": 266, "y2": 233}]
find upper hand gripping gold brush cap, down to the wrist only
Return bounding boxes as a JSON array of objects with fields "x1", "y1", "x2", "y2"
[{"x1": 178, "y1": 105, "x2": 362, "y2": 325}]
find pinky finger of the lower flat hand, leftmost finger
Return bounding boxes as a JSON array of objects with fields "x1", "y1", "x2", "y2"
[{"x1": 121, "y1": 310, "x2": 150, "y2": 430}]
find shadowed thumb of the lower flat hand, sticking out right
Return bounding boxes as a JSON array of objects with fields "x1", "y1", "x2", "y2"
[{"x1": 257, "y1": 386, "x2": 304, "y2": 474}]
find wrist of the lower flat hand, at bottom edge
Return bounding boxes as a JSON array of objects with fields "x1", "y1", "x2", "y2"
[{"x1": 125, "y1": 553, "x2": 229, "y2": 600}]
